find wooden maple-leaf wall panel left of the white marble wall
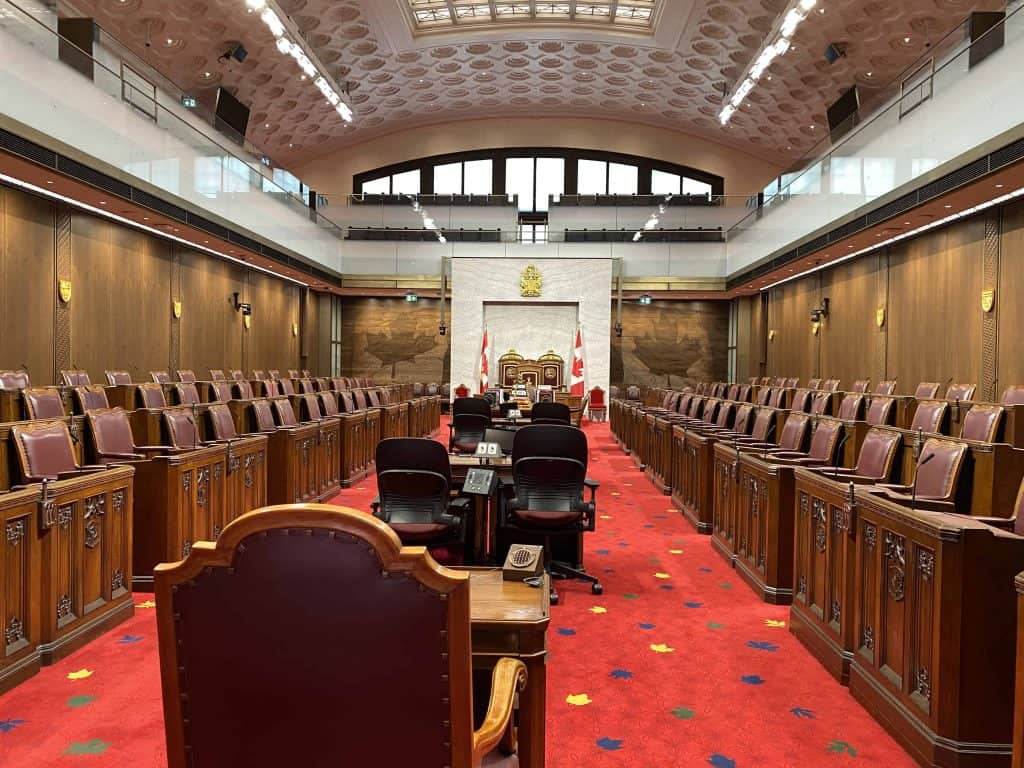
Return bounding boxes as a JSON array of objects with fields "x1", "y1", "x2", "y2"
[{"x1": 341, "y1": 297, "x2": 452, "y2": 384}]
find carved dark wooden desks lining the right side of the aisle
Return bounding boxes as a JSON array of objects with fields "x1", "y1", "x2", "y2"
[{"x1": 617, "y1": 391, "x2": 1024, "y2": 768}]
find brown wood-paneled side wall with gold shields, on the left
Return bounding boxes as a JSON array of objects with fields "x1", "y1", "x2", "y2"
[{"x1": 0, "y1": 180, "x2": 311, "y2": 384}]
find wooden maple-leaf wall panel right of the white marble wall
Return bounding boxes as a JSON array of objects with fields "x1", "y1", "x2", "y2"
[{"x1": 611, "y1": 301, "x2": 729, "y2": 387}]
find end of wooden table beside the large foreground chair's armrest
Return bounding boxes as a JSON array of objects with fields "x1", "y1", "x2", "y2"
[{"x1": 466, "y1": 568, "x2": 551, "y2": 768}]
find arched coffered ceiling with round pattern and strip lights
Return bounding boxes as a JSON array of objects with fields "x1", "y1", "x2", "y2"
[{"x1": 61, "y1": 0, "x2": 1002, "y2": 164}]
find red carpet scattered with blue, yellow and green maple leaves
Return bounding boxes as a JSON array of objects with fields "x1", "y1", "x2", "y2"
[{"x1": 0, "y1": 424, "x2": 914, "y2": 768}]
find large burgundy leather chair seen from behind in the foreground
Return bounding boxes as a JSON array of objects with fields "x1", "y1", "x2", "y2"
[{"x1": 154, "y1": 512, "x2": 526, "y2": 768}]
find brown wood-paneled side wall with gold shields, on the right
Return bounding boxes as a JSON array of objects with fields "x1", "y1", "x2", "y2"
[{"x1": 736, "y1": 196, "x2": 1024, "y2": 399}]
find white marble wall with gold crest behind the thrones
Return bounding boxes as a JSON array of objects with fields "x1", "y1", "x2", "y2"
[{"x1": 451, "y1": 257, "x2": 612, "y2": 397}]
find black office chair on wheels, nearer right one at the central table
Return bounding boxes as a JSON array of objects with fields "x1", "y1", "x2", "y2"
[{"x1": 501, "y1": 424, "x2": 603, "y2": 604}]
